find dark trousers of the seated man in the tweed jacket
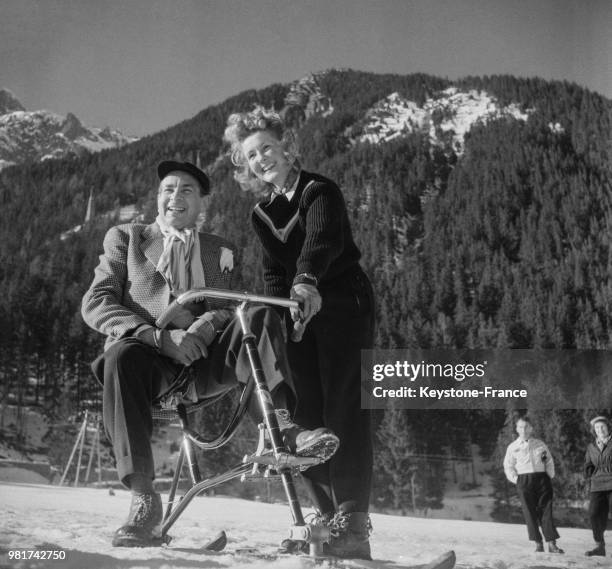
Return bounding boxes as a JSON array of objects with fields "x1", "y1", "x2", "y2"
[{"x1": 92, "y1": 307, "x2": 293, "y2": 485}]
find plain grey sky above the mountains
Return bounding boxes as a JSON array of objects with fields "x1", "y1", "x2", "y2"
[{"x1": 0, "y1": 0, "x2": 612, "y2": 136}]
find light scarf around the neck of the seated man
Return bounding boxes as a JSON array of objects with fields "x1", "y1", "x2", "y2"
[{"x1": 155, "y1": 215, "x2": 206, "y2": 296}]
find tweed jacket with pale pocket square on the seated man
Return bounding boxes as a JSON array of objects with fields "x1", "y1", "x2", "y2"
[{"x1": 81, "y1": 223, "x2": 236, "y2": 349}]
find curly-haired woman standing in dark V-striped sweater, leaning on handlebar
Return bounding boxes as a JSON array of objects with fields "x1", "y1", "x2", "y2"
[{"x1": 225, "y1": 107, "x2": 374, "y2": 559}]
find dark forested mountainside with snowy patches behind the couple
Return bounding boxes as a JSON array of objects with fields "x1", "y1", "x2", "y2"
[{"x1": 0, "y1": 70, "x2": 612, "y2": 516}]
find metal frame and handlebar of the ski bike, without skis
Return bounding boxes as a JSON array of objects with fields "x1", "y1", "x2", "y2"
[{"x1": 154, "y1": 288, "x2": 330, "y2": 556}]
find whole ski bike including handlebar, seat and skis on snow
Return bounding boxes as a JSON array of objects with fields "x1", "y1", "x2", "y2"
[{"x1": 153, "y1": 288, "x2": 455, "y2": 569}]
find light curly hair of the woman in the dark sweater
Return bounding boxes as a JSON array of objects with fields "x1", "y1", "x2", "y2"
[{"x1": 223, "y1": 105, "x2": 299, "y2": 195}]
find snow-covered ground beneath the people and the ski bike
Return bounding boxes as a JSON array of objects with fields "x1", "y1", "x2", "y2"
[{"x1": 0, "y1": 483, "x2": 612, "y2": 569}]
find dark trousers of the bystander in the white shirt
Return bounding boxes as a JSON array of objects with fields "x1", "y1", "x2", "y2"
[{"x1": 516, "y1": 472, "x2": 559, "y2": 542}]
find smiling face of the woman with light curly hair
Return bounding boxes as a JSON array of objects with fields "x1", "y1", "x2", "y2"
[{"x1": 242, "y1": 130, "x2": 292, "y2": 188}]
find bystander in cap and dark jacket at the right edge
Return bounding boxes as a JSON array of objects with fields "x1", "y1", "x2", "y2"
[{"x1": 584, "y1": 416, "x2": 612, "y2": 557}]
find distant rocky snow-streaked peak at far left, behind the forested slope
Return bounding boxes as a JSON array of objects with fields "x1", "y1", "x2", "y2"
[{"x1": 0, "y1": 89, "x2": 137, "y2": 169}]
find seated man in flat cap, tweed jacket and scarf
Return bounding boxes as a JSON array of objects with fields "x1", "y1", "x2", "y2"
[{"x1": 82, "y1": 161, "x2": 338, "y2": 547}]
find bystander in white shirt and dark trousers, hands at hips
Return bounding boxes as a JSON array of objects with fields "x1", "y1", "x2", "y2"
[{"x1": 504, "y1": 417, "x2": 563, "y2": 553}]
